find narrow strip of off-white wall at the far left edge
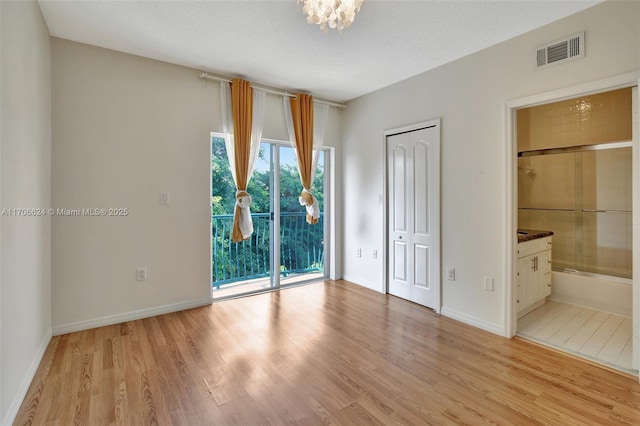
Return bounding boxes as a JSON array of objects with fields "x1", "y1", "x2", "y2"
[{"x1": 0, "y1": 1, "x2": 51, "y2": 425}]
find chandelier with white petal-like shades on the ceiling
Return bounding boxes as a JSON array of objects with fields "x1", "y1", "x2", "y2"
[{"x1": 298, "y1": 0, "x2": 364, "y2": 32}]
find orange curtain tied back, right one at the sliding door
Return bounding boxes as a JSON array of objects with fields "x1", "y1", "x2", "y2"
[{"x1": 289, "y1": 93, "x2": 318, "y2": 225}]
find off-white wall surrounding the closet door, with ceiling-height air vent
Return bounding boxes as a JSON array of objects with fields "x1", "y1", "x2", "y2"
[{"x1": 343, "y1": 2, "x2": 640, "y2": 333}]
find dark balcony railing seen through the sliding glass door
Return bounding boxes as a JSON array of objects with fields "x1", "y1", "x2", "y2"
[{"x1": 211, "y1": 211, "x2": 324, "y2": 288}]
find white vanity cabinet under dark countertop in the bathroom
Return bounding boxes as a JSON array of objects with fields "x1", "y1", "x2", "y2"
[{"x1": 516, "y1": 237, "x2": 551, "y2": 318}]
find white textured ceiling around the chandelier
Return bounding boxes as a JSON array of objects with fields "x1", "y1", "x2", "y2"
[{"x1": 39, "y1": 0, "x2": 601, "y2": 101}]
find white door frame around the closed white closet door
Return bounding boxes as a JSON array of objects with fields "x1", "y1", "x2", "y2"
[{"x1": 378, "y1": 118, "x2": 442, "y2": 314}]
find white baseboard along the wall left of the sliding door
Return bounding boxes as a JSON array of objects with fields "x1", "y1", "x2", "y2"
[{"x1": 53, "y1": 298, "x2": 213, "y2": 336}]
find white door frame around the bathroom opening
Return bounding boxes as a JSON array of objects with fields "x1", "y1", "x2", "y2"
[{"x1": 504, "y1": 71, "x2": 640, "y2": 376}]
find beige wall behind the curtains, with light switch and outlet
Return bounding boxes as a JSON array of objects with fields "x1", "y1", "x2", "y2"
[{"x1": 52, "y1": 38, "x2": 340, "y2": 334}]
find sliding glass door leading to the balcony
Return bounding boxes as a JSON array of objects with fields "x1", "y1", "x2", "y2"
[{"x1": 211, "y1": 136, "x2": 327, "y2": 298}]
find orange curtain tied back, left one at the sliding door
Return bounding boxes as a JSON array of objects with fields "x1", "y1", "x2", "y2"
[{"x1": 230, "y1": 78, "x2": 253, "y2": 242}]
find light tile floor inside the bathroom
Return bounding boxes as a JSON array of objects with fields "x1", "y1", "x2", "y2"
[{"x1": 517, "y1": 301, "x2": 637, "y2": 374}]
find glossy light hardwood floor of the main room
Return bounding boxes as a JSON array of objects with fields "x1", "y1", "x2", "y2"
[{"x1": 15, "y1": 281, "x2": 640, "y2": 426}]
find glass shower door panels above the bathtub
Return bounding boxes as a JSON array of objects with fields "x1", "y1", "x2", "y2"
[{"x1": 518, "y1": 147, "x2": 633, "y2": 278}]
